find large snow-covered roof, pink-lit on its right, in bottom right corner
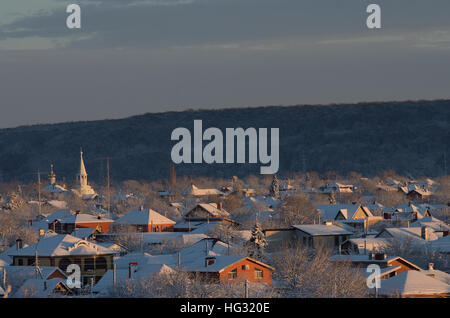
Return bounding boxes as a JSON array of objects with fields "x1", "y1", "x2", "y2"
[{"x1": 378, "y1": 270, "x2": 450, "y2": 296}]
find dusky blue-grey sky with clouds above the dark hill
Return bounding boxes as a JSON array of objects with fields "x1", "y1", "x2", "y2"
[{"x1": 0, "y1": 0, "x2": 450, "y2": 128}]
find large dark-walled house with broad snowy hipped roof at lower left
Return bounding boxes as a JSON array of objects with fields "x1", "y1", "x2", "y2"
[{"x1": 10, "y1": 233, "x2": 116, "y2": 284}]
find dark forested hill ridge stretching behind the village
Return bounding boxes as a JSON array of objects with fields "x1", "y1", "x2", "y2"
[{"x1": 0, "y1": 100, "x2": 450, "y2": 182}]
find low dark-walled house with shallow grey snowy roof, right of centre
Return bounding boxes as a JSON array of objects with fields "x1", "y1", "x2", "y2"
[{"x1": 292, "y1": 222, "x2": 353, "y2": 249}]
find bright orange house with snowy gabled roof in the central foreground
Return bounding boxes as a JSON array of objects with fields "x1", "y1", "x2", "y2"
[{"x1": 182, "y1": 255, "x2": 275, "y2": 286}]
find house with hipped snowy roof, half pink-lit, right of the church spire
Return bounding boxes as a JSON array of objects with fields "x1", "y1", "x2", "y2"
[{"x1": 114, "y1": 207, "x2": 176, "y2": 232}]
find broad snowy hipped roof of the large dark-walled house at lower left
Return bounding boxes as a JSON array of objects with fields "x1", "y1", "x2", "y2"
[{"x1": 9, "y1": 234, "x2": 116, "y2": 256}]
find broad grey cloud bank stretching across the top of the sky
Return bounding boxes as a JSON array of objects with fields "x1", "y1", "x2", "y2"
[{"x1": 5, "y1": 0, "x2": 450, "y2": 48}]
